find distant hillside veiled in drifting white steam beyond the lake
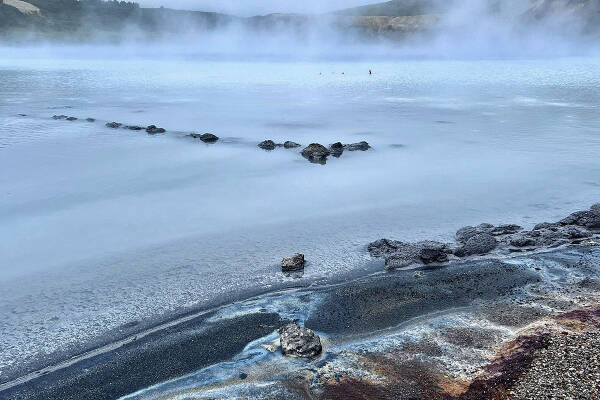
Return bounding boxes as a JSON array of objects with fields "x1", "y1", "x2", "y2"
[{"x1": 0, "y1": 0, "x2": 600, "y2": 42}]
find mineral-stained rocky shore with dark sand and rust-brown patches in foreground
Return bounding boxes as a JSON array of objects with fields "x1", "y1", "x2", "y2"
[{"x1": 0, "y1": 205, "x2": 600, "y2": 400}]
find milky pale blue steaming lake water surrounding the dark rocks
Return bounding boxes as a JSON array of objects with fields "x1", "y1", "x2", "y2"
[{"x1": 0, "y1": 49, "x2": 600, "y2": 382}]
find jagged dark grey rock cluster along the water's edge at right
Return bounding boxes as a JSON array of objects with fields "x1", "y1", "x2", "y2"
[{"x1": 368, "y1": 203, "x2": 600, "y2": 269}]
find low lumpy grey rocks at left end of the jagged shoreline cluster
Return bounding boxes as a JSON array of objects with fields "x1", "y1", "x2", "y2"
[{"x1": 368, "y1": 239, "x2": 451, "y2": 270}]
